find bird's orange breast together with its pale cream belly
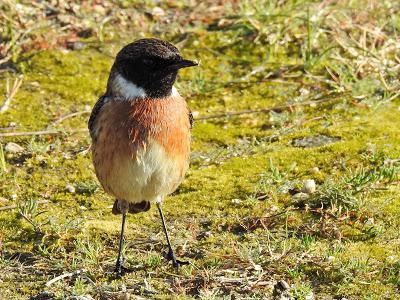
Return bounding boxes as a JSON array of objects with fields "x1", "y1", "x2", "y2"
[{"x1": 92, "y1": 97, "x2": 190, "y2": 202}]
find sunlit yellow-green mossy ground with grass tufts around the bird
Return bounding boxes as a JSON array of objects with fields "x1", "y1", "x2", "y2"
[{"x1": 0, "y1": 1, "x2": 400, "y2": 299}]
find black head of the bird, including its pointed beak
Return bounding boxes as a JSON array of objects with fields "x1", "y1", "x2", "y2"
[{"x1": 114, "y1": 38, "x2": 197, "y2": 98}]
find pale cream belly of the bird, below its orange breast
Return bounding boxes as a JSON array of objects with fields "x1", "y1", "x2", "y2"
[{"x1": 95, "y1": 140, "x2": 188, "y2": 203}]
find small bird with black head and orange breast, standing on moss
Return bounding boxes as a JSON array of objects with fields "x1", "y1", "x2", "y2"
[{"x1": 88, "y1": 38, "x2": 197, "y2": 275}]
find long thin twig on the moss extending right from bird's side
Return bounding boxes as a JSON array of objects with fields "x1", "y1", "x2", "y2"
[{"x1": 196, "y1": 95, "x2": 343, "y2": 120}]
